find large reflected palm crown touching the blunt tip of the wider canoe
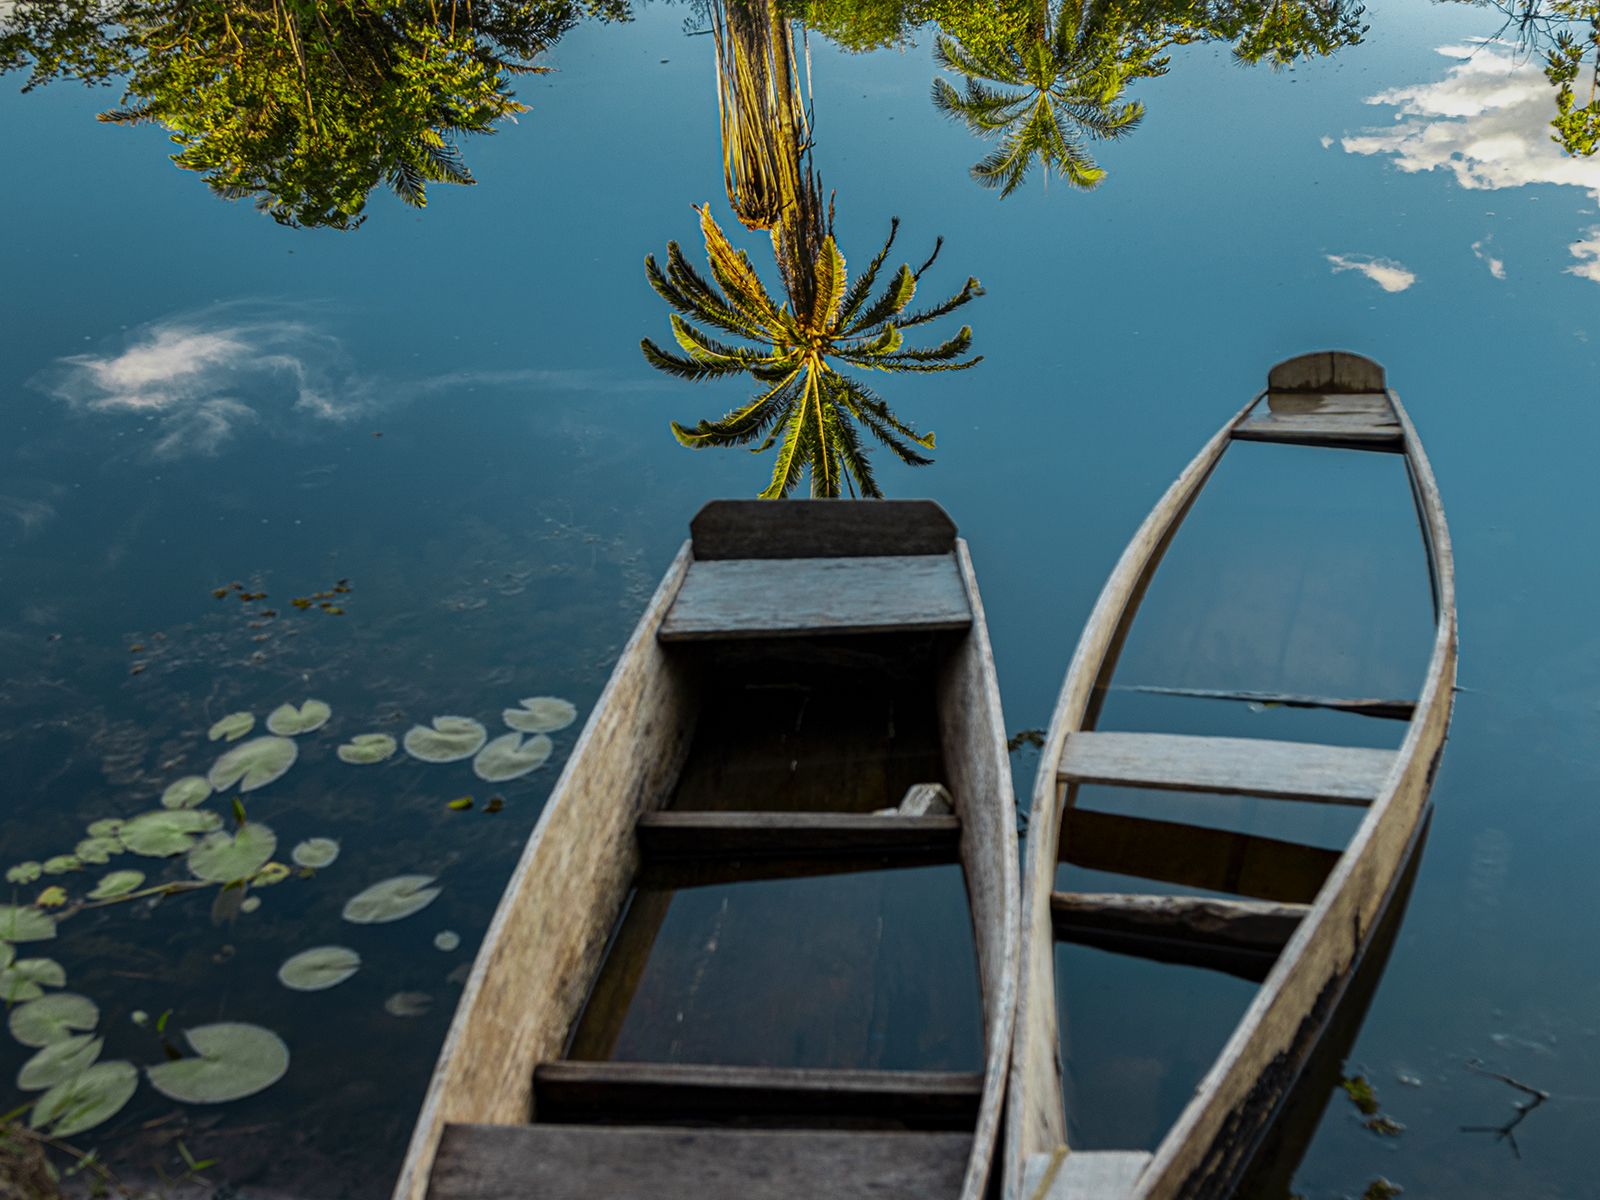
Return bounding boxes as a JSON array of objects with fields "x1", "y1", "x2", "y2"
[{"x1": 642, "y1": 205, "x2": 982, "y2": 499}]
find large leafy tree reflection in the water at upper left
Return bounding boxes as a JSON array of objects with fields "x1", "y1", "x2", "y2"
[{"x1": 0, "y1": 0, "x2": 601, "y2": 229}]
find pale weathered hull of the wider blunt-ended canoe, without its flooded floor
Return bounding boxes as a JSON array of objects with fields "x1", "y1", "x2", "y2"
[{"x1": 394, "y1": 501, "x2": 1018, "y2": 1200}]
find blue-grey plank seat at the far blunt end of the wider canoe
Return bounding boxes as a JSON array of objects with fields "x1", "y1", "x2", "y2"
[{"x1": 659, "y1": 554, "x2": 973, "y2": 642}]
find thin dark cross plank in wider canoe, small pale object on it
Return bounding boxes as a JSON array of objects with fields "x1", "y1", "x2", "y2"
[{"x1": 638, "y1": 811, "x2": 962, "y2": 862}]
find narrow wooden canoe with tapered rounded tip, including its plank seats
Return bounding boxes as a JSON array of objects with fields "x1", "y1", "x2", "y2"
[{"x1": 1003, "y1": 352, "x2": 1456, "y2": 1200}]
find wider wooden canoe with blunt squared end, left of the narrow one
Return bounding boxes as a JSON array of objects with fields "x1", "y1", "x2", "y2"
[{"x1": 394, "y1": 501, "x2": 1021, "y2": 1200}]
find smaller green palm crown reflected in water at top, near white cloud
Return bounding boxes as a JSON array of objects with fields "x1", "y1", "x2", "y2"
[{"x1": 933, "y1": 0, "x2": 1166, "y2": 195}]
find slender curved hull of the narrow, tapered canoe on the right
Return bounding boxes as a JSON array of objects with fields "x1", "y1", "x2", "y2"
[{"x1": 1005, "y1": 354, "x2": 1456, "y2": 1200}]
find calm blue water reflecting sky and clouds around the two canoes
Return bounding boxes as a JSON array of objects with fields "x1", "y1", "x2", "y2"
[{"x1": 0, "y1": 3, "x2": 1600, "y2": 1200}]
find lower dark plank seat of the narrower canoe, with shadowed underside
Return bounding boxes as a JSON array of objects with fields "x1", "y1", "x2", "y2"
[{"x1": 1050, "y1": 891, "x2": 1310, "y2": 982}]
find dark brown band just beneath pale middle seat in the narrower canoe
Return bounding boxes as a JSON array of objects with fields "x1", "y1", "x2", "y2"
[{"x1": 1061, "y1": 808, "x2": 1339, "y2": 904}]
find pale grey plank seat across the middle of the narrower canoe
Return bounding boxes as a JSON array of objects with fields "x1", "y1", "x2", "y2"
[{"x1": 1061, "y1": 731, "x2": 1395, "y2": 805}]
